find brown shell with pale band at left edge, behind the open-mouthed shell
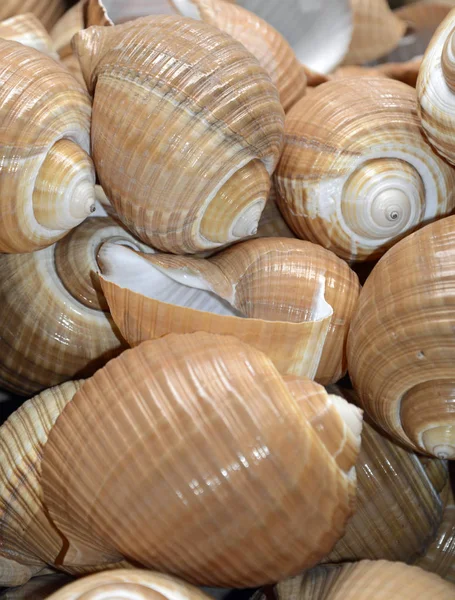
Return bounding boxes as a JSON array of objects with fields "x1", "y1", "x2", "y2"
[{"x1": 0, "y1": 217, "x2": 148, "y2": 395}]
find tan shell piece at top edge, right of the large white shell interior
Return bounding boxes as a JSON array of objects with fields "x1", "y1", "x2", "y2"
[{"x1": 344, "y1": 0, "x2": 407, "y2": 65}]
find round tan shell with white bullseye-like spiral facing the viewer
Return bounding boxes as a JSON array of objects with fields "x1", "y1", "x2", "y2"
[{"x1": 275, "y1": 78, "x2": 455, "y2": 260}]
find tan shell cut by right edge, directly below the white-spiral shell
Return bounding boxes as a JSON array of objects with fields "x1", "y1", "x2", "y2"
[{"x1": 348, "y1": 217, "x2": 455, "y2": 458}]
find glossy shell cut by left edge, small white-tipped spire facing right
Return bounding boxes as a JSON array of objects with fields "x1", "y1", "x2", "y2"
[{"x1": 0, "y1": 40, "x2": 95, "y2": 253}]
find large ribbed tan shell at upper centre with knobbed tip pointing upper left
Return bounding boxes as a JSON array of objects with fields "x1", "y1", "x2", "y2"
[{"x1": 73, "y1": 16, "x2": 284, "y2": 253}]
